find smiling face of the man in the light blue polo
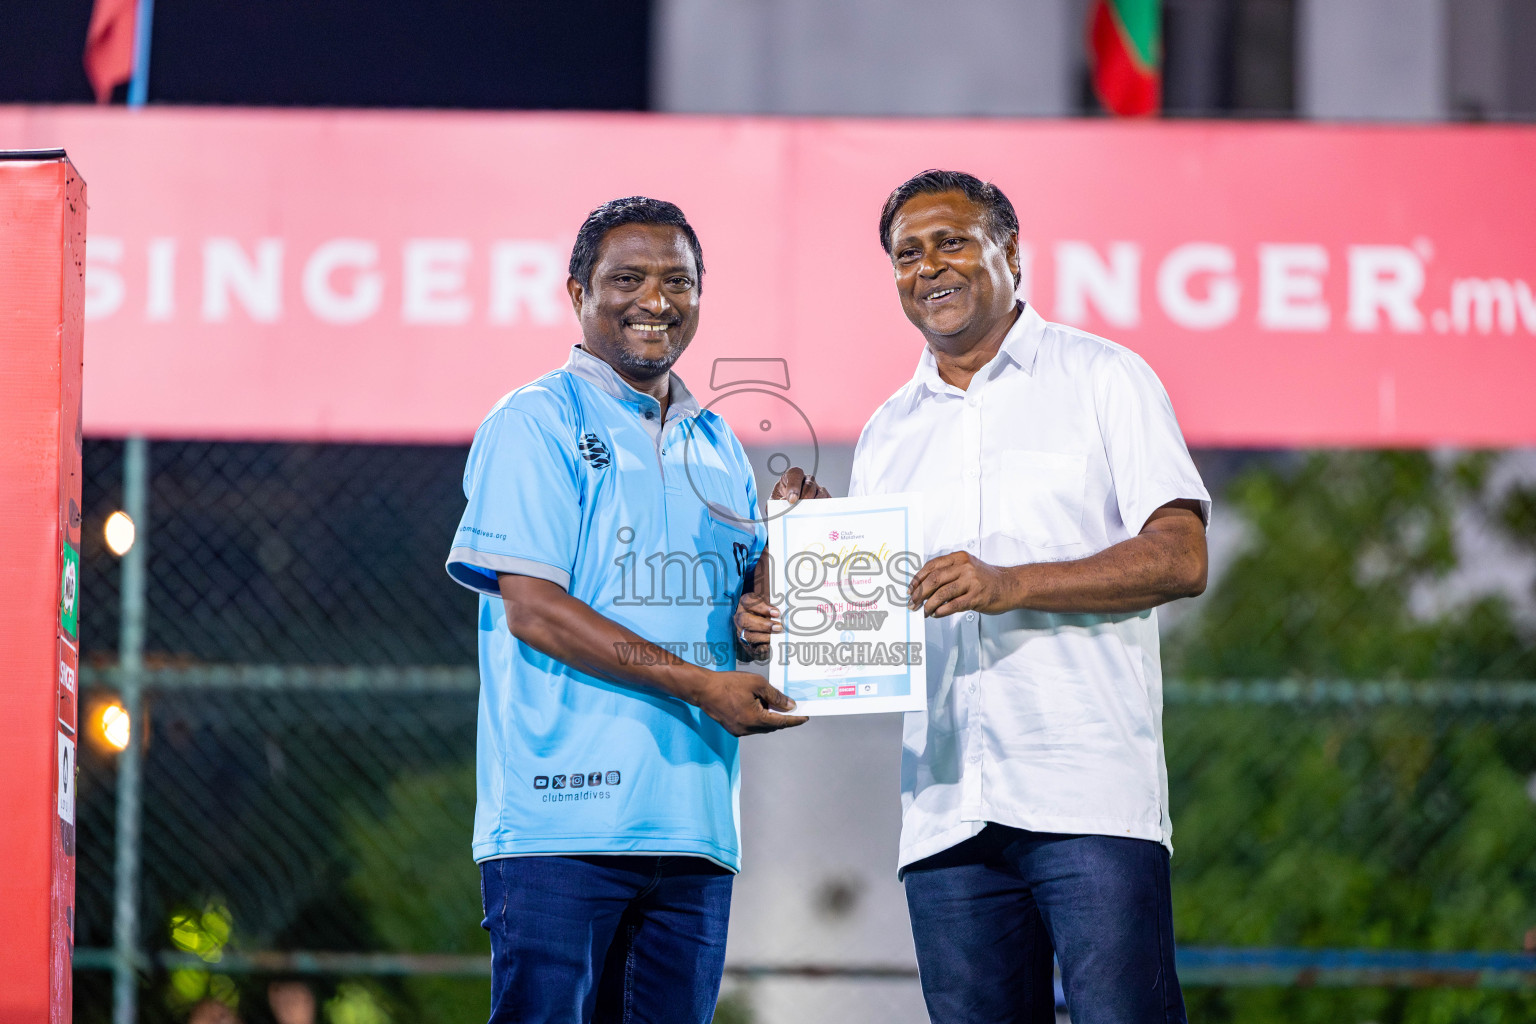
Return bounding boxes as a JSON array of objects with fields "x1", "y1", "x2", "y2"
[{"x1": 565, "y1": 224, "x2": 699, "y2": 385}]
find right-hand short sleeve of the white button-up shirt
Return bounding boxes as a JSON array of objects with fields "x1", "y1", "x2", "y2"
[{"x1": 1095, "y1": 350, "x2": 1210, "y2": 534}]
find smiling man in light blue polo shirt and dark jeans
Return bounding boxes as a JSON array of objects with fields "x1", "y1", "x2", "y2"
[{"x1": 447, "y1": 197, "x2": 805, "y2": 1024}]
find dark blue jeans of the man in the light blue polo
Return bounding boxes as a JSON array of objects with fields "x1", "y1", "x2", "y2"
[{"x1": 481, "y1": 855, "x2": 733, "y2": 1024}]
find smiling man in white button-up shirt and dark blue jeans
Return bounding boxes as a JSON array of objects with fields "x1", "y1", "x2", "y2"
[{"x1": 737, "y1": 170, "x2": 1210, "y2": 1024}]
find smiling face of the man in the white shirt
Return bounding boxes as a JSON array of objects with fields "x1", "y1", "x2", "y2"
[{"x1": 891, "y1": 192, "x2": 1018, "y2": 350}]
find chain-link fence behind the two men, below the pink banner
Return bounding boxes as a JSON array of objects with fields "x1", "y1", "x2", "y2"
[{"x1": 75, "y1": 441, "x2": 1536, "y2": 1024}]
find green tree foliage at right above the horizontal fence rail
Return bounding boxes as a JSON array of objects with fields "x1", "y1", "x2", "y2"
[{"x1": 1164, "y1": 451, "x2": 1536, "y2": 679}]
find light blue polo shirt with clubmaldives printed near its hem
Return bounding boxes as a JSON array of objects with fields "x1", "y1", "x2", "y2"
[{"x1": 447, "y1": 347, "x2": 766, "y2": 870}]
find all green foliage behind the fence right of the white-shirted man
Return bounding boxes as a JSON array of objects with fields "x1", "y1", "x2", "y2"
[{"x1": 1166, "y1": 451, "x2": 1536, "y2": 1024}]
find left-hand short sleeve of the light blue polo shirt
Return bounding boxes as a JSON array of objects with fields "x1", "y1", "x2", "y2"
[{"x1": 447, "y1": 408, "x2": 581, "y2": 597}]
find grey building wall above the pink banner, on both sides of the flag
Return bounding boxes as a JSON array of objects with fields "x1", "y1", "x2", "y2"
[{"x1": 651, "y1": 0, "x2": 1536, "y2": 121}]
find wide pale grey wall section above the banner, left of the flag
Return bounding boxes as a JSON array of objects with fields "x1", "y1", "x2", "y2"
[{"x1": 651, "y1": 0, "x2": 1083, "y2": 117}]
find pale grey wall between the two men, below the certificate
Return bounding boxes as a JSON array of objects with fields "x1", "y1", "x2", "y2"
[{"x1": 727, "y1": 714, "x2": 928, "y2": 1024}]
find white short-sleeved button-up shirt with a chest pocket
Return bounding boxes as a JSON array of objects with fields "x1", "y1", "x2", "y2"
[{"x1": 849, "y1": 306, "x2": 1210, "y2": 867}]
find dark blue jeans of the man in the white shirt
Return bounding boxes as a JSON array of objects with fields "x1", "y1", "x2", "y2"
[{"x1": 905, "y1": 824, "x2": 1187, "y2": 1024}]
